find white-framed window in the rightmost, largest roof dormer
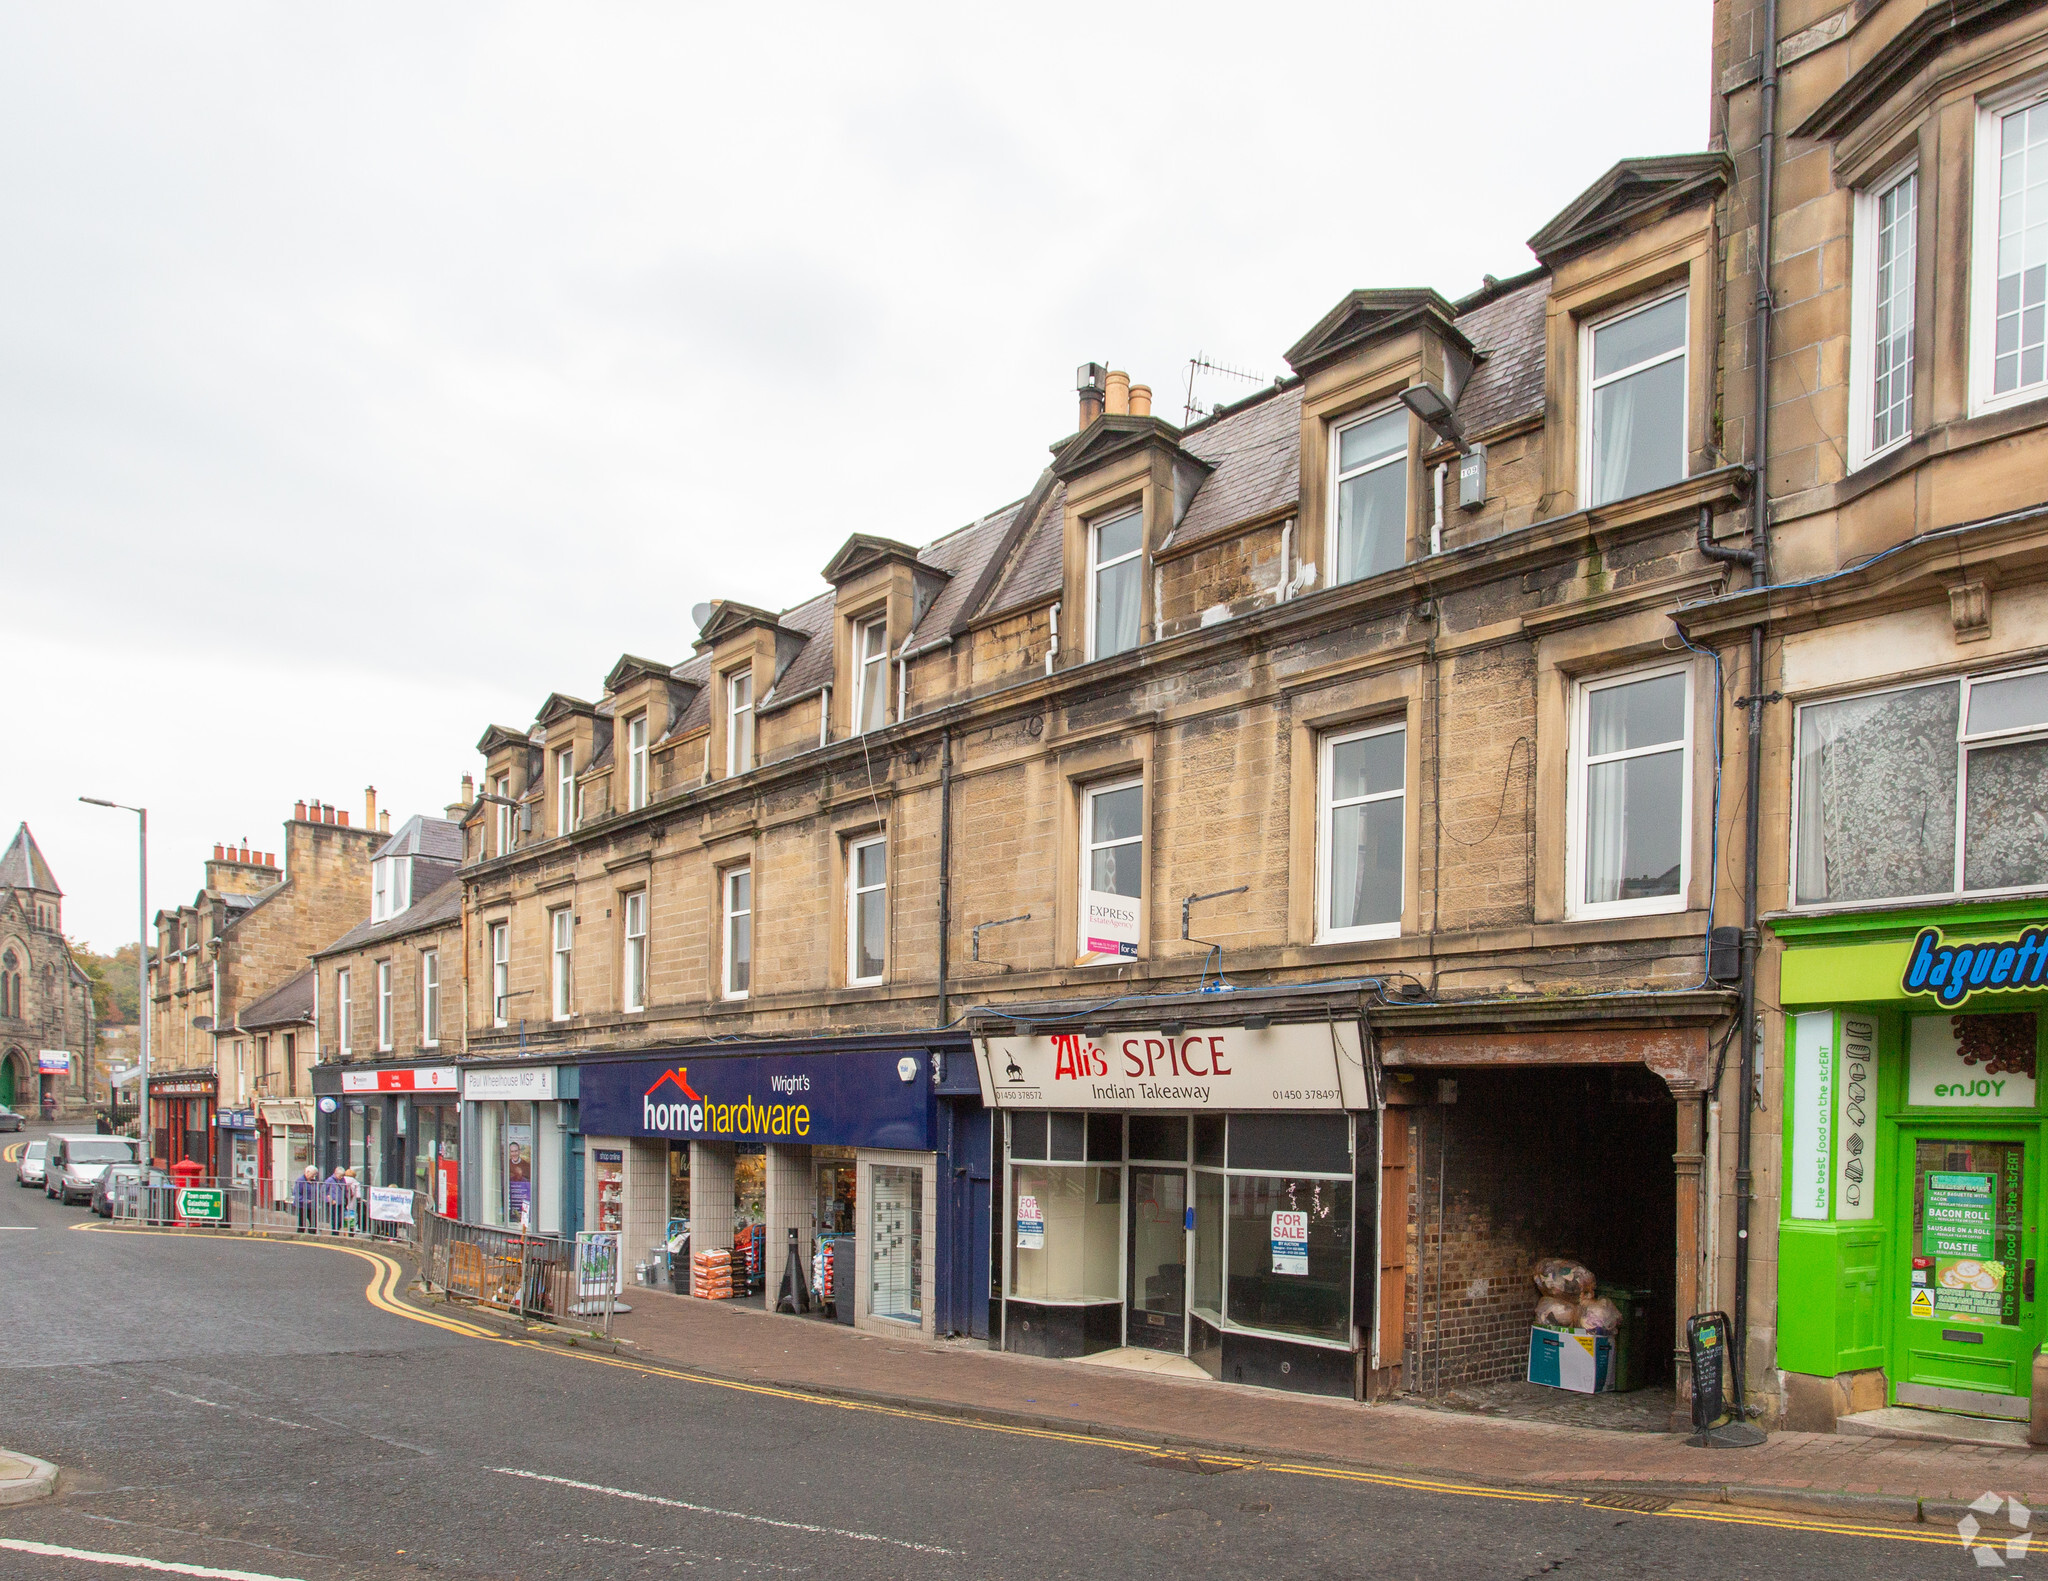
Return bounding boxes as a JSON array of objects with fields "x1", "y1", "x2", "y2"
[{"x1": 1585, "y1": 291, "x2": 1686, "y2": 506}]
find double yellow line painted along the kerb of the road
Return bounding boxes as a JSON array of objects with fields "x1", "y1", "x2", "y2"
[{"x1": 72, "y1": 1223, "x2": 1964, "y2": 1548}]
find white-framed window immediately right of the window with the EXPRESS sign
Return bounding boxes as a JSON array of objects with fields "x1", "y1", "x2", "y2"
[{"x1": 1321, "y1": 725, "x2": 1407, "y2": 938}]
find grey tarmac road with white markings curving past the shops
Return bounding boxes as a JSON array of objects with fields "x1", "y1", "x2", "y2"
[{"x1": 0, "y1": 1133, "x2": 2015, "y2": 1581}]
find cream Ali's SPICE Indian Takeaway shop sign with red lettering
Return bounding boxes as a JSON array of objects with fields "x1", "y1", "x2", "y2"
[{"x1": 975, "y1": 1022, "x2": 1370, "y2": 1110}]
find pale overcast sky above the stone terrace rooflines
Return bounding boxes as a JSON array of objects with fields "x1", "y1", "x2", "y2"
[{"x1": 0, "y1": 0, "x2": 1710, "y2": 948}]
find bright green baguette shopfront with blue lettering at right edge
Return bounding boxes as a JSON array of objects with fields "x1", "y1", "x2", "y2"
[{"x1": 1772, "y1": 899, "x2": 2048, "y2": 1427}]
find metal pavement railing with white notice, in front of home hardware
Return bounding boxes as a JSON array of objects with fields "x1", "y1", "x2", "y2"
[{"x1": 418, "y1": 1204, "x2": 621, "y2": 1335}]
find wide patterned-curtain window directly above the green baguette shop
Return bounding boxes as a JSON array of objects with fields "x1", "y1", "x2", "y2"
[{"x1": 1794, "y1": 670, "x2": 2048, "y2": 905}]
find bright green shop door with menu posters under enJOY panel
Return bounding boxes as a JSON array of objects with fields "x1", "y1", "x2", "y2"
[{"x1": 1892, "y1": 1124, "x2": 2040, "y2": 1419}]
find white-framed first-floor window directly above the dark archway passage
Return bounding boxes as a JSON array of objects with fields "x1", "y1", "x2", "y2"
[{"x1": 1577, "y1": 670, "x2": 1692, "y2": 911}]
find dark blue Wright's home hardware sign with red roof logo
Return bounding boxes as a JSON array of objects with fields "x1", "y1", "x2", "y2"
[{"x1": 580, "y1": 1049, "x2": 932, "y2": 1151}]
